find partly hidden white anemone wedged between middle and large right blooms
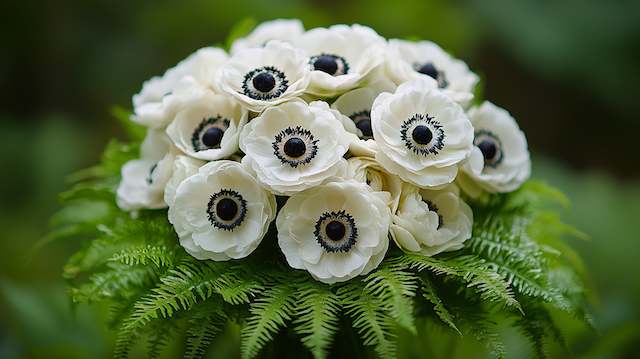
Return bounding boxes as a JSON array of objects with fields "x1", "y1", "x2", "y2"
[{"x1": 331, "y1": 79, "x2": 396, "y2": 157}]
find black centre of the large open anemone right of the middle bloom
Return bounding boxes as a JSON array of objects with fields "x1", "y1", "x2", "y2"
[{"x1": 400, "y1": 114, "x2": 446, "y2": 156}]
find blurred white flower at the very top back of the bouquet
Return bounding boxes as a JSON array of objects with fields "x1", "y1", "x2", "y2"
[{"x1": 231, "y1": 19, "x2": 304, "y2": 55}]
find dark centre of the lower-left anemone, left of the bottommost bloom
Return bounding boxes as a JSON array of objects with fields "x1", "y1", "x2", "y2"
[{"x1": 207, "y1": 189, "x2": 247, "y2": 231}]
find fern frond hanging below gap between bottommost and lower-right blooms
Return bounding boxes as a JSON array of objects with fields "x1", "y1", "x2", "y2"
[{"x1": 364, "y1": 261, "x2": 417, "y2": 334}]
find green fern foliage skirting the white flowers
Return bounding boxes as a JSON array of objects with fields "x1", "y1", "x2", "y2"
[{"x1": 51, "y1": 142, "x2": 588, "y2": 358}]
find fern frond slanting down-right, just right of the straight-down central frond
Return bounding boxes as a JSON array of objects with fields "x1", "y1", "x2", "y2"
[{"x1": 338, "y1": 282, "x2": 396, "y2": 358}]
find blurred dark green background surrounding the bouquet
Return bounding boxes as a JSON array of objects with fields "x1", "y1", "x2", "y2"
[{"x1": 0, "y1": 0, "x2": 640, "y2": 358}]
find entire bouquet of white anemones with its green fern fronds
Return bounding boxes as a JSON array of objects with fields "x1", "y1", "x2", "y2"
[{"x1": 53, "y1": 20, "x2": 588, "y2": 358}]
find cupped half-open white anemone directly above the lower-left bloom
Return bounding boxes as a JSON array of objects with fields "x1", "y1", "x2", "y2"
[{"x1": 167, "y1": 91, "x2": 248, "y2": 161}]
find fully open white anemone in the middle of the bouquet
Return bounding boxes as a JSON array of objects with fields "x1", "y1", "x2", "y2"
[{"x1": 240, "y1": 101, "x2": 351, "y2": 195}]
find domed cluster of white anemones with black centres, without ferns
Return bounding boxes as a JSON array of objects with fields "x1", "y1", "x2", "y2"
[{"x1": 117, "y1": 20, "x2": 530, "y2": 283}]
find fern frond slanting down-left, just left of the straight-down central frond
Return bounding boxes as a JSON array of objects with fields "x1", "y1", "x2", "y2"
[{"x1": 240, "y1": 282, "x2": 296, "y2": 359}]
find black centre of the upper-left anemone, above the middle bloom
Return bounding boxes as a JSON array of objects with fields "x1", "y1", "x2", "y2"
[{"x1": 242, "y1": 66, "x2": 289, "y2": 100}]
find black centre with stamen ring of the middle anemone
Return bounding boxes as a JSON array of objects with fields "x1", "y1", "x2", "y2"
[{"x1": 271, "y1": 126, "x2": 318, "y2": 168}]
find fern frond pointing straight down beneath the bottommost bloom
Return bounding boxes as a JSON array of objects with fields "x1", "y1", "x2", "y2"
[{"x1": 293, "y1": 283, "x2": 340, "y2": 359}]
